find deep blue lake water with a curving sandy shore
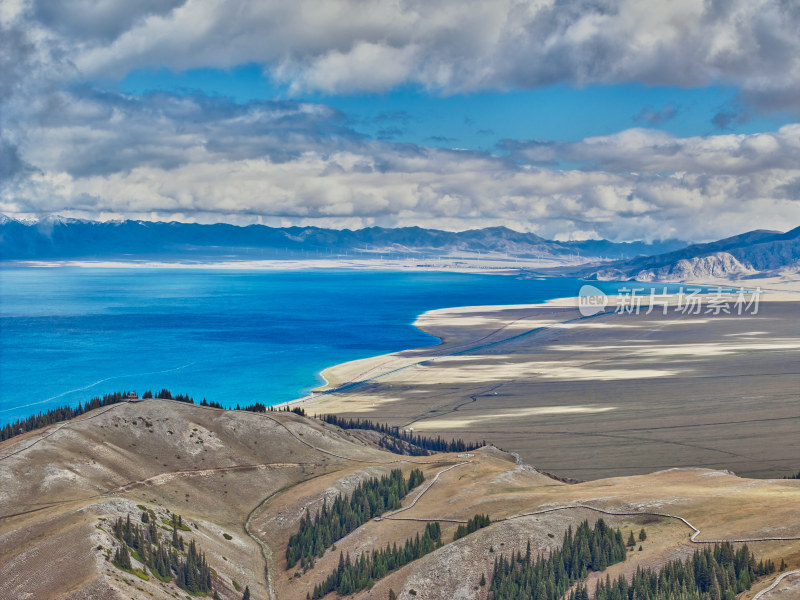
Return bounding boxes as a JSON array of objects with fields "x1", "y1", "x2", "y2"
[{"x1": 0, "y1": 267, "x2": 636, "y2": 425}]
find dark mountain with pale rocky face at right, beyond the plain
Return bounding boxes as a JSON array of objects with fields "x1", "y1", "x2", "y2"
[{"x1": 577, "y1": 227, "x2": 800, "y2": 281}]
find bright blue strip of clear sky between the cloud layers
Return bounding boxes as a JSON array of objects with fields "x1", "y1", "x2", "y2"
[{"x1": 115, "y1": 64, "x2": 793, "y2": 153}]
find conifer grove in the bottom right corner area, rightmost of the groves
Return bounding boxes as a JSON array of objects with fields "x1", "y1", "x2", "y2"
[{"x1": 570, "y1": 542, "x2": 775, "y2": 600}]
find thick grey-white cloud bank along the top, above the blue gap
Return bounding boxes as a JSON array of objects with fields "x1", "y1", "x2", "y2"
[{"x1": 26, "y1": 0, "x2": 800, "y2": 110}]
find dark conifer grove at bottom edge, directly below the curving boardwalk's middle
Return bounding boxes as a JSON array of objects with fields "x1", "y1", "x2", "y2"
[{"x1": 489, "y1": 519, "x2": 627, "y2": 600}]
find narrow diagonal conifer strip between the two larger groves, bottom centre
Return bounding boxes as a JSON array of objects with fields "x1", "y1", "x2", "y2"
[{"x1": 312, "y1": 523, "x2": 442, "y2": 599}]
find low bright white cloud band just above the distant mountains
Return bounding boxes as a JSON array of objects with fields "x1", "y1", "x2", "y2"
[{"x1": 2, "y1": 151, "x2": 800, "y2": 240}]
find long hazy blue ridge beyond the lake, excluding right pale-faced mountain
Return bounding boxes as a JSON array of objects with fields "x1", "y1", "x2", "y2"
[{"x1": 0, "y1": 215, "x2": 687, "y2": 262}]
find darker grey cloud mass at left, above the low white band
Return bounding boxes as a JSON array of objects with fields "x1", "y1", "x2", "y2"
[{"x1": 23, "y1": 88, "x2": 357, "y2": 177}]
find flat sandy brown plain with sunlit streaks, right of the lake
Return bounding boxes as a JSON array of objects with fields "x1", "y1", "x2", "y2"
[{"x1": 302, "y1": 277, "x2": 800, "y2": 479}]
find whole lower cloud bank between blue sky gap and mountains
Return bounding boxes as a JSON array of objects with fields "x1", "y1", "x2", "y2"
[{"x1": 0, "y1": 89, "x2": 800, "y2": 240}]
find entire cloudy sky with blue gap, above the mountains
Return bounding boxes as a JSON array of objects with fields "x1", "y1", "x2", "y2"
[{"x1": 0, "y1": 0, "x2": 800, "y2": 241}]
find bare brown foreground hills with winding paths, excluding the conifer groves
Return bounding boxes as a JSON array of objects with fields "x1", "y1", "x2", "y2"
[{"x1": 0, "y1": 400, "x2": 800, "y2": 600}]
